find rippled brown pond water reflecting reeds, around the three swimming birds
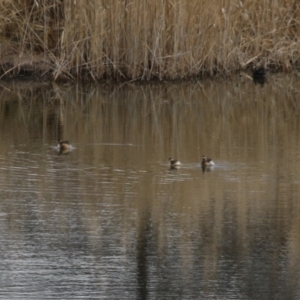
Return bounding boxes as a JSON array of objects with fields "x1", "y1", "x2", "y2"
[{"x1": 0, "y1": 74, "x2": 300, "y2": 299}]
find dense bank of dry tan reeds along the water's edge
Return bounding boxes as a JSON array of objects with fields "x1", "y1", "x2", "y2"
[{"x1": 0, "y1": 0, "x2": 300, "y2": 80}]
